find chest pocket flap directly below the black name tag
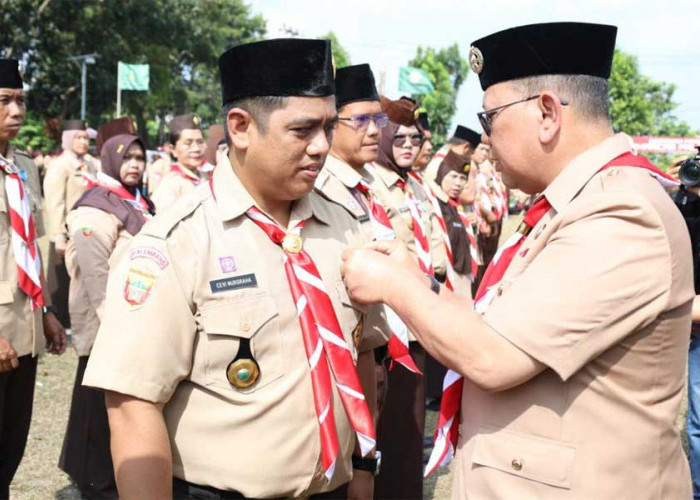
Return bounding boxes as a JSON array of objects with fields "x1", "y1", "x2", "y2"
[{"x1": 201, "y1": 295, "x2": 278, "y2": 339}]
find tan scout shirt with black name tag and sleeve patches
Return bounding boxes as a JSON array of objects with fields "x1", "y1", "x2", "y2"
[{"x1": 84, "y1": 161, "x2": 380, "y2": 498}]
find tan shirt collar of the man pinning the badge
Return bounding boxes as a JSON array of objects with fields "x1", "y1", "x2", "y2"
[{"x1": 543, "y1": 134, "x2": 630, "y2": 212}]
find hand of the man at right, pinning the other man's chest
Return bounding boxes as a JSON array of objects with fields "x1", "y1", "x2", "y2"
[{"x1": 340, "y1": 241, "x2": 422, "y2": 304}]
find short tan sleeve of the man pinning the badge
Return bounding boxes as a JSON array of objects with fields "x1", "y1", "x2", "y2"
[{"x1": 484, "y1": 192, "x2": 671, "y2": 380}]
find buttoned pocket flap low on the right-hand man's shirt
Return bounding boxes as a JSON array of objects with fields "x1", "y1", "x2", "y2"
[{"x1": 472, "y1": 428, "x2": 576, "y2": 489}]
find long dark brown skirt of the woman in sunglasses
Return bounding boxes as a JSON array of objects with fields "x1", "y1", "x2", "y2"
[{"x1": 374, "y1": 342, "x2": 425, "y2": 499}]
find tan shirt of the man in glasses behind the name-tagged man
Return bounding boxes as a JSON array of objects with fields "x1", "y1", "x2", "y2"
[{"x1": 315, "y1": 155, "x2": 391, "y2": 352}]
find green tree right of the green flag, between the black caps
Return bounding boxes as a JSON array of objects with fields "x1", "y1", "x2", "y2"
[{"x1": 408, "y1": 43, "x2": 469, "y2": 149}]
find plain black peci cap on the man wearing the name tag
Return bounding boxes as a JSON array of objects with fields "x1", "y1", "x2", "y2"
[{"x1": 219, "y1": 38, "x2": 335, "y2": 104}]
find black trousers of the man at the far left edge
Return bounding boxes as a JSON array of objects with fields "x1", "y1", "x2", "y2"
[{"x1": 0, "y1": 354, "x2": 37, "y2": 499}]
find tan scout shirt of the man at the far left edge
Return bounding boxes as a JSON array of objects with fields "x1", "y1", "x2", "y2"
[{"x1": 0, "y1": 145, "x2": 44, "y2": 356}]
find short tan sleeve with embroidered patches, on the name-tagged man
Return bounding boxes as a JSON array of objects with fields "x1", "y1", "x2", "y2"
[{"x1": 83, "y1": 229, "x2": 197, "y2": 403}]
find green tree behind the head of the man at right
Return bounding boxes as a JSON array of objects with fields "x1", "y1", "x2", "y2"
[{"x1": 610, "y1": 50, "x2": 696, "y2": 136}]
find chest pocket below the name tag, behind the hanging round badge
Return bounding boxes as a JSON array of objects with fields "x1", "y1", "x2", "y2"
[{"x1": 200, "y1": 293, "x2": 284, "y2": 394}]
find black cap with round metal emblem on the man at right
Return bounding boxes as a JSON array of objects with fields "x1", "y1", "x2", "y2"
[{"x1": 469, "y1": 23, "x2": 617, "y2": 90}]
